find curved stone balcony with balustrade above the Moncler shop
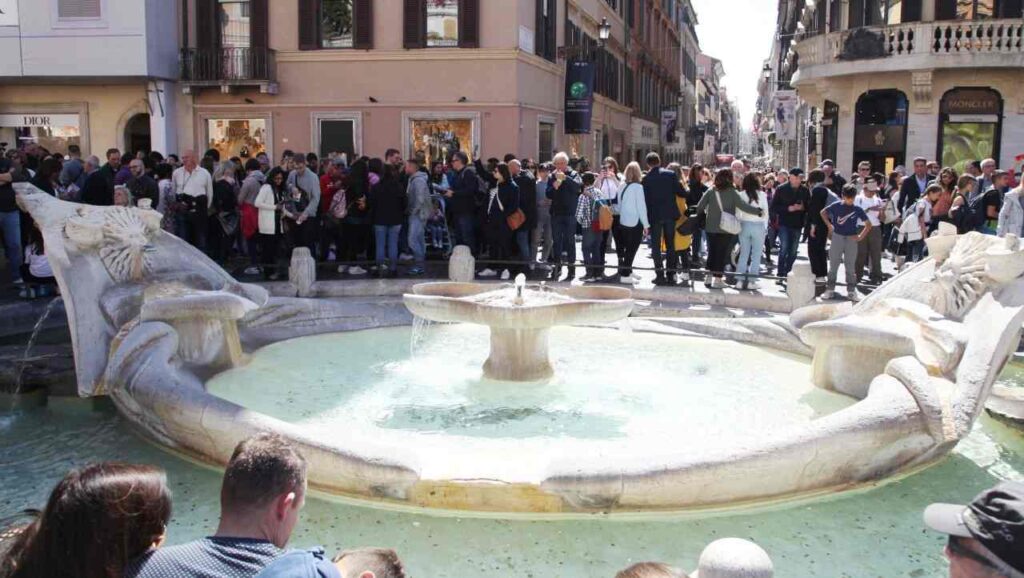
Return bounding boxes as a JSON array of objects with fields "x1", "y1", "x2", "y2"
[{"x1": 793, "y1": 18, "x2": 1024, "y2": 86}]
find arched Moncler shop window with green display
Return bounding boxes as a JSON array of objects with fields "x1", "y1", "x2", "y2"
[{"x1": 938, "y1": 88, "x2": 1002, "y2": 173}]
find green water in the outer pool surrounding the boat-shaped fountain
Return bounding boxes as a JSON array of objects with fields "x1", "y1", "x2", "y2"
[{"x1": 0, "y1": 329, "x2": 1024, "y2": 578}]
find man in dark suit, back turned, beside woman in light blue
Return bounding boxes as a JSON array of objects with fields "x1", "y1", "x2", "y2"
[{"x1": 642, "y1": 153, "x2": 684, "y2": 286}]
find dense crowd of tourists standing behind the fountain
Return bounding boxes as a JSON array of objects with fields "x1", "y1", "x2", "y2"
[{"x1": 0, "y1": 141, "x2": 1024, "y2": 299}]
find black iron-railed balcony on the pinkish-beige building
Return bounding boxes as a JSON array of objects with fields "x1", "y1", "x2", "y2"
[{"x1": 181, "y1": 48, "x2": 278, "y2": 94}]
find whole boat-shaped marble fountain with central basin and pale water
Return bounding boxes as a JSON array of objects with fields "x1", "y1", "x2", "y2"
[{"x1": 15, "y1": 180, "x2": 1024, "y2": 514}]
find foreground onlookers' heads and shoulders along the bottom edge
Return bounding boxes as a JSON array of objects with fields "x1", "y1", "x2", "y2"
[{"x1": 0, "y1": 434, "x2": 1024, "y2": 578}]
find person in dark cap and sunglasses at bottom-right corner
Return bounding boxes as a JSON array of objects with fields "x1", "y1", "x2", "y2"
[{"x1": 925, "y1": 482, "x2": 1024, "y2": 578}]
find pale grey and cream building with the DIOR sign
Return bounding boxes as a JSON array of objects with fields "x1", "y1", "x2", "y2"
[{"x1": 0, "y1": 0, "x2": 180, "y2": 153}]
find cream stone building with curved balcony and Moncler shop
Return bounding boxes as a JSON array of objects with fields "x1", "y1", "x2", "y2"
[{"x1": 781, "y1": 0, "x2": 1024, "y2": 176}]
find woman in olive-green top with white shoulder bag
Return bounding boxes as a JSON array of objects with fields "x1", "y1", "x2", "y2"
[{"x1": 692, "y1": 169, "x2": 765, "y2": 289}]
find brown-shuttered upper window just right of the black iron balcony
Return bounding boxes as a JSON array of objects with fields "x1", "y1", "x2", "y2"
[{"x1": 299, "y1": 0, "x2": 374, "y2": 50}]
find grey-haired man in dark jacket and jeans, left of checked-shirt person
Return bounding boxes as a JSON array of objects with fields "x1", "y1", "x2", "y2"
[{"x1": 547, "y1": 153, "x2": 583, "y2": 283}]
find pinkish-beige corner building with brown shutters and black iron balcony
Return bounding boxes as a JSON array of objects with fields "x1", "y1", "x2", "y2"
[{"x1": 181, "y1": 0, "x2": 645, "y2": 167}]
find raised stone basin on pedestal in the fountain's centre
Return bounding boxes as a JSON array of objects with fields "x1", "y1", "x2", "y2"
[{"x1": 404, "y1": 274, "x2": 633, "y2": 381}]
